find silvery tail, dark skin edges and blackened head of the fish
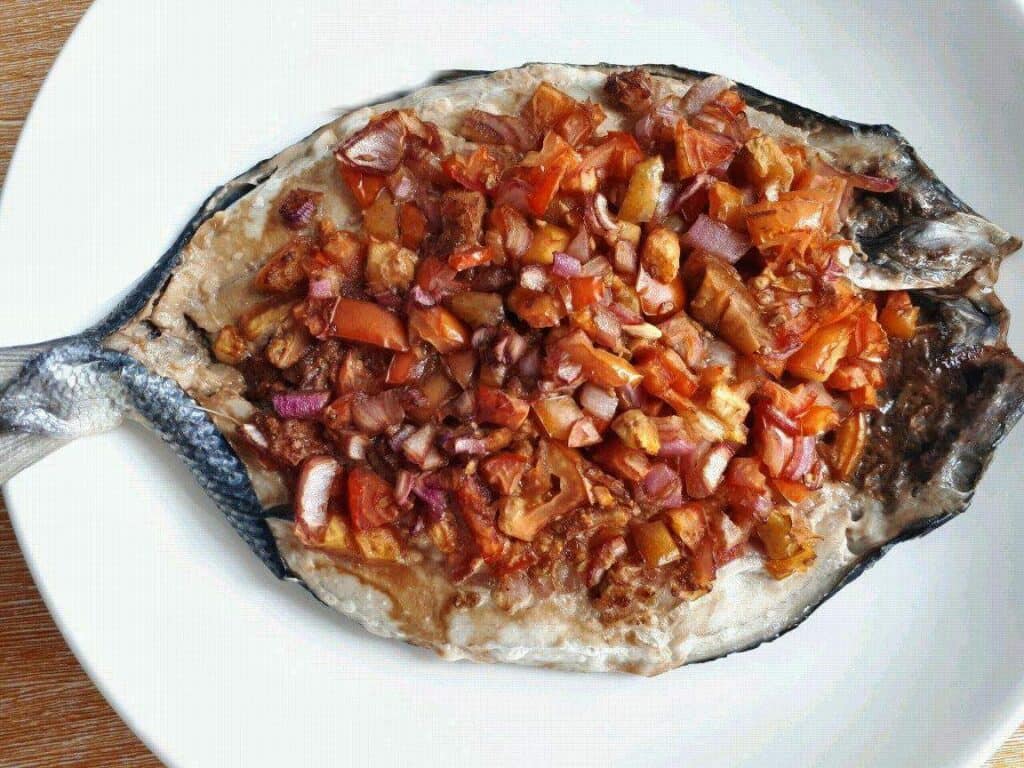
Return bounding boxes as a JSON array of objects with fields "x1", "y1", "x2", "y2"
[{"x1": 0, "y1": 65, "x2": 1024, "y2": 660}]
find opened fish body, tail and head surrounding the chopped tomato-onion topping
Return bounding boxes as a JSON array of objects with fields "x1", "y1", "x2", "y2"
[{"x1": 0, "y1": 65, "x2": 1024, "y2": 674}]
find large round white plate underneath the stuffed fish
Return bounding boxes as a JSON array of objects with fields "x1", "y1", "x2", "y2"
[{"x1": 0, "y1": 0, "x2": 1024, "y2": 767}]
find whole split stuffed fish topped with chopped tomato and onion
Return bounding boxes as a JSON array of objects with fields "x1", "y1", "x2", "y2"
[{"x1": 0, "y1": 65, "x2": 1024, "y2": 675}]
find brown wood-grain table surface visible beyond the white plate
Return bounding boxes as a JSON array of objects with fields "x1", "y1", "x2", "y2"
[{"x1": 0, "y1": 0, "x2": 1024, "y2": 768}]
